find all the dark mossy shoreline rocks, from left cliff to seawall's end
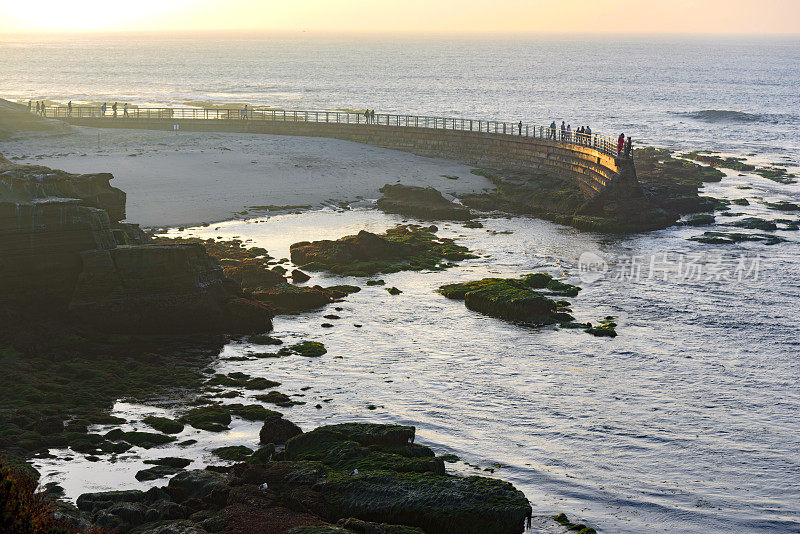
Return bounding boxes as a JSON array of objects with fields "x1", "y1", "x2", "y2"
[{"x1": 0, "y1": 111, "x2": 764, "y2": 534}]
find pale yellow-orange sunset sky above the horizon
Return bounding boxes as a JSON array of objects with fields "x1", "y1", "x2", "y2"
[{"x1": 0, "y1": 0, "x2": 800, "y2": 34}]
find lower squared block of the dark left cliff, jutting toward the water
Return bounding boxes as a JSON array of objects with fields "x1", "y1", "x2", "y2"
[{"x1": 69, "y1": 245, "x2": 274, "y2": 333}]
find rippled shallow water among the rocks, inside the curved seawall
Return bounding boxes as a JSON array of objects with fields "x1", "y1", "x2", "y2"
[{"x1": 31, "y1": 165, "x2": 800, "y2": 532}]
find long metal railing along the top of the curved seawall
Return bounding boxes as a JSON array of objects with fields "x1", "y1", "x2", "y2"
[{"x1": 36, "y1": 106, "x2": 621, "y2": 157}]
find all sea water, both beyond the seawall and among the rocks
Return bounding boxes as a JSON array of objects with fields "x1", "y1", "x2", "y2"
[{"x1": 0, "y1": 35, "x2": 800, "y2": 533}]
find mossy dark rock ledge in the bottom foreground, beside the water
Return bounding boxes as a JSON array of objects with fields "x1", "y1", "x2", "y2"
[{"x1": 65, "y1": 423, "x2": 532, "y2": 534}]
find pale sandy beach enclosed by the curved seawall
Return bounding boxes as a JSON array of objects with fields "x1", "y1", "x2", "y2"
[{"x1": 0, "y1": 128, "x2": 491, "y2": 227}]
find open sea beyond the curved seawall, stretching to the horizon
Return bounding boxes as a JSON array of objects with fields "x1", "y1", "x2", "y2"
[{"x1": 0, "y1": 33, "x2": 800, "y2": 164}]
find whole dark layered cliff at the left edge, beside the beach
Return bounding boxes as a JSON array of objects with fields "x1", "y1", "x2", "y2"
[{"x1": 0, "y1": 156, "x2": 274, "y2": 333}]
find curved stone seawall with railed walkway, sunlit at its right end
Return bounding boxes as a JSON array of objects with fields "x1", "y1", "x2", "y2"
[{"x1": 47, "y1": 107, "x2": 641, "y2": 200}]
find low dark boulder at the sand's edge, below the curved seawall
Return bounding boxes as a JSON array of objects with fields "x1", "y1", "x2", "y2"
[{"x1": 378, "y1": 184, "x2": 472, "y2": 221}]
